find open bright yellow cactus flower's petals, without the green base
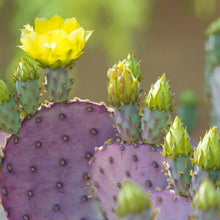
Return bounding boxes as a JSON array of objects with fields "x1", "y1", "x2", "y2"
[{"x1": 19, "y1": 15, "x2": 92, "y2": 69}]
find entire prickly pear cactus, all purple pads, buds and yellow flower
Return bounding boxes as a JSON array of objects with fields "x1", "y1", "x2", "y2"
[{"x1": 0, "y1": 13, "x2": 220, "y2": 220}]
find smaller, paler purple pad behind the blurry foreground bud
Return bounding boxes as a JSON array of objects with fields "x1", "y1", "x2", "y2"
[{"x1": 90, "y1": 143, "x2": 167, "y2": 220}]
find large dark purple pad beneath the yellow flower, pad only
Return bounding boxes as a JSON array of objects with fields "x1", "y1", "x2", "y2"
[{"x1": 0, "y1": 100, "x2": 114, "y2": 220}]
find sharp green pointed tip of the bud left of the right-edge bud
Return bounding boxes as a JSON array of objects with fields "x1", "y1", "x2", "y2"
[{"x1": 163, "y1": 117, "x2": 192, "y2": 158}]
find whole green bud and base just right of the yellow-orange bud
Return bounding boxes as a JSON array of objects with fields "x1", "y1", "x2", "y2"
[{"x1": 141, "y1": 74, "x2": 173, "y2": 145}]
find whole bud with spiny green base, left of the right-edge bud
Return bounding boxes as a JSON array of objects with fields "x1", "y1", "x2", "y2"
[{"x1": 163, "y1": 117, "x2": 193, "y2": 196}]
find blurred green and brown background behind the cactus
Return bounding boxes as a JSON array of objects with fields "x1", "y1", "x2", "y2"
[{"x1": 0, "y1": 0, "x2": 220, "y2": 138}]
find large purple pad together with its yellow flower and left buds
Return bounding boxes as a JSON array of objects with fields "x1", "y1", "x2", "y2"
[{"x1": 0, "y1": 16, "x2": 115, "y2": 220}]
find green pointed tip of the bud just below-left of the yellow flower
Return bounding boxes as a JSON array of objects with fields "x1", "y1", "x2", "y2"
[{"x1": 14, "y1": 58, "x2": 39, "y2": 82}]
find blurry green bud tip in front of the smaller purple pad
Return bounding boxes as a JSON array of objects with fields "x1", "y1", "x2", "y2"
[{"x1": 116, "y1": 181, "x2": 152, "y2": 218}]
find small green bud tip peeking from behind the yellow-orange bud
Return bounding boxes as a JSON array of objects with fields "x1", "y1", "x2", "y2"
[{"x1": 122, "y1": 53, "x2": 142, "y2": 80}]
